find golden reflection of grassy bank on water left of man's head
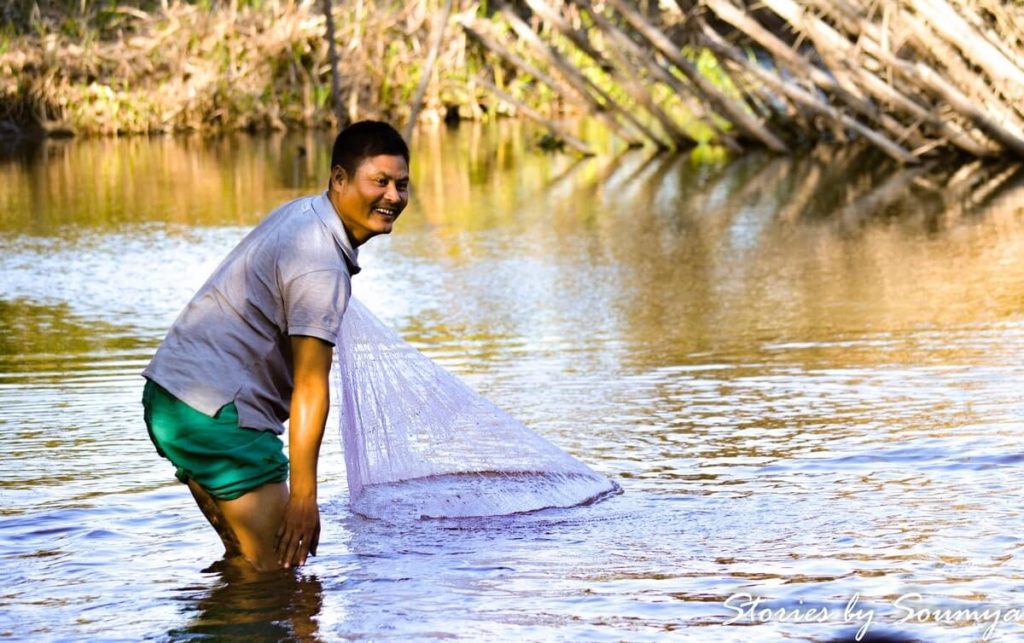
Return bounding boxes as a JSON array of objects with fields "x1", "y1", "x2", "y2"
[{"x1": 0, "y1": 133, "x2": 331, "y2": 232}]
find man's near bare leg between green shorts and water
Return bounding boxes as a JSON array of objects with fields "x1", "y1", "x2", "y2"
[{"x1": 209, "y1": 482, "x2": 288, "y2": 571}]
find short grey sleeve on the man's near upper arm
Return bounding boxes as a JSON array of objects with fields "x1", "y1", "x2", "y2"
[{"x1": 284, "y1": 269, "x2": 350, "y2": 346}]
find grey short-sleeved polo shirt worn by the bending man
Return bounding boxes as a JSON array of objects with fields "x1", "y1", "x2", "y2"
[{"x1": 142, "y1": 192, "x2": 359, "y2": 433}]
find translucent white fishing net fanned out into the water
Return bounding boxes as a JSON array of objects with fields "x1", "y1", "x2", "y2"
[{"x1": 337, "y1": 297, "x2": 620, "y2": 520}]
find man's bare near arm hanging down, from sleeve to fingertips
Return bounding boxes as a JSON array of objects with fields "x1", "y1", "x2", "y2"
[{"x1": 274, "y1": 336, "x2": 334, "y2": 567}]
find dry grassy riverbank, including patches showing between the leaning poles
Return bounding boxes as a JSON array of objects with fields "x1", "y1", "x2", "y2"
[{"x1": 0, "y1": 0, "x2": 736, "y2": 153}]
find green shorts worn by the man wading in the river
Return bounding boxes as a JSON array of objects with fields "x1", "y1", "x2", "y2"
[{"x1": 142, "y1": 380, "x2": 288, "y2": 500}]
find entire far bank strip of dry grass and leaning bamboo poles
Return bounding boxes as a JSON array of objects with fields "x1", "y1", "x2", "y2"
[{"x1": 6, "y1": 0, "x2": 1024, "y2": 165}]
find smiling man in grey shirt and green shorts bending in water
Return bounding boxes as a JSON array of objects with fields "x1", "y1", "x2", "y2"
[{"x1": 142, "y1": 121, "x2": 409, "y2": 570}]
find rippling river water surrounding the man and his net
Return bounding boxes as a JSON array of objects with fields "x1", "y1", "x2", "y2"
[{"x1": 0, "y1": 122, "x2": 1024, "y2": 641}]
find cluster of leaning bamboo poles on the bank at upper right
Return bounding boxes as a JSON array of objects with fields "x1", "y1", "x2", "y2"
[{"x1": 460, "y1": 0, "x2": 1024, "y2": 165}]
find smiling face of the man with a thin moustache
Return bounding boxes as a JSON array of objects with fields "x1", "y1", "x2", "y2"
[{"x1": 329, "y1": 155, "x2": 409, "y2": 246}]
